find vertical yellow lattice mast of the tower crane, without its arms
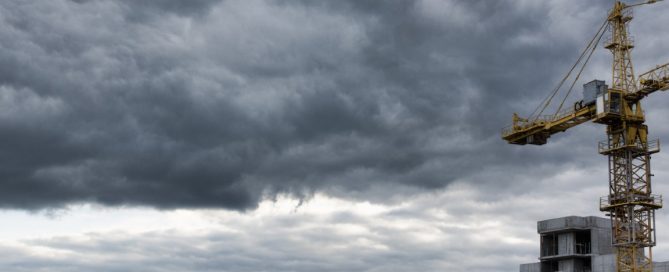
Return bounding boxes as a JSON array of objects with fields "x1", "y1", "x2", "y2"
[{"x1": 595, "y1": 2, "x2": 662, "y2": 272}]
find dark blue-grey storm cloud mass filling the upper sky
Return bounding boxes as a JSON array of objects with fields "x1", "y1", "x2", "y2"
[{"x1": 0, "y1": 0, "x2": 668, "y2": 209}]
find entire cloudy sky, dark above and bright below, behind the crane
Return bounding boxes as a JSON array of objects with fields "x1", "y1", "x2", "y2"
[{"x1": 0, "y1": 0, "x2": 669, "y2": 271}]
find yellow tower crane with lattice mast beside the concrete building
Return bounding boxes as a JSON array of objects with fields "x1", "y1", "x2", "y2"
[{"x1": 502, "y1": 0, "x2": 669, "y2": 272}]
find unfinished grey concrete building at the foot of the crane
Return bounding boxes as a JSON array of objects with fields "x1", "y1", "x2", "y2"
[{"x1": 520, "y1": 216, "x2": 669, "y2": 272}]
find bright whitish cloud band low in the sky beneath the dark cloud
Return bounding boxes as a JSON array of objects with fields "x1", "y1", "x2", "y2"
[{"x1": 0, "y1": 190, "x2": 590, "y2": 272}]
